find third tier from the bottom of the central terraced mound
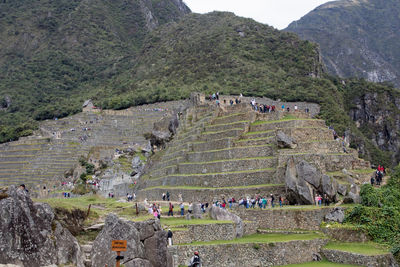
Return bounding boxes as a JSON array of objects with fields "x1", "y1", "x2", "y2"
[{"x1": 178, "y1": 157, "x2": 277, "y2": 174}]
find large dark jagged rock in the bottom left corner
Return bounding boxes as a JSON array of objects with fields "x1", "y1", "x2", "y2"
[{"x1": 0, "y1": 186, "x2": 83, "y2": 267}]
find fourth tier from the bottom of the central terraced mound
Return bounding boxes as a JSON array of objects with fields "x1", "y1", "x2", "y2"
[{"x1": 185, "y1": 145, "x2": 276, "y2": 162}]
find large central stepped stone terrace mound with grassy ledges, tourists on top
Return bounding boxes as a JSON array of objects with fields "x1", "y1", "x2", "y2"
[{"x1": 137, "y1": 97, "x2": 370, "y2": 201}]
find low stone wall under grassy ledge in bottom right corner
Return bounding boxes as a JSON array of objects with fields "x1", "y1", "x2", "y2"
[{"x1": 322, "y1": 249, "x2": 399, "y2": 267}]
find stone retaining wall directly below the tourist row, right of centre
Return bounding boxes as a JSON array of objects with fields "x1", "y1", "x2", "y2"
[{"x1": 233, "y1": 207, "x2": 332, "y2": 230}]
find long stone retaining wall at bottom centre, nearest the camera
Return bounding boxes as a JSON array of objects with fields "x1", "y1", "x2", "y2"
[{"x1": 169, "y1": 239, "x2": 327, "y2": 267}]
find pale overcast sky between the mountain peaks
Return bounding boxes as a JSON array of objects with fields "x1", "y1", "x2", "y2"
[{"x1": 183, "y1": 0, "x2": 331, "y2": 29}]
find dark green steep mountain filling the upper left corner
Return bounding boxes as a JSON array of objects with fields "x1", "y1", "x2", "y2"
[{"x1": 0, "y1": 0, "x2": 190, "y2": 142}]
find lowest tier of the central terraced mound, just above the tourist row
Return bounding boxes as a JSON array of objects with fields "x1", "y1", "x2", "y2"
[{"x1": 137, "y1": 184, "x2": 285, "y2": 203}]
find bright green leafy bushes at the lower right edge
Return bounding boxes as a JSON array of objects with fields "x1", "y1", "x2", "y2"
[{"x1": 346, "y1": 166, "x2": 400, "y2": 259}]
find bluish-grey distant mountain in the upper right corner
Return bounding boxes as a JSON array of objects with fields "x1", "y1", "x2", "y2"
[{"x1": 285, "y1": 0, "x2": 400, "y2": 87}]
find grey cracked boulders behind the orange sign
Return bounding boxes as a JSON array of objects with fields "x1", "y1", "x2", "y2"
[{"x1": 92, "y1": 214, "x2": 171, "y2": 267}]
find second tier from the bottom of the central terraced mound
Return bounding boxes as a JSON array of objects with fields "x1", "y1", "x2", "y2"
[{"x1": 140, "y1": 169, "x2": 276, "y2": 188}]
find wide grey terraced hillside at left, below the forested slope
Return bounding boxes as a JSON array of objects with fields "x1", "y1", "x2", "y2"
[{"x1": 0, "y1": 101, "x2": 187, "y2": 191}]
